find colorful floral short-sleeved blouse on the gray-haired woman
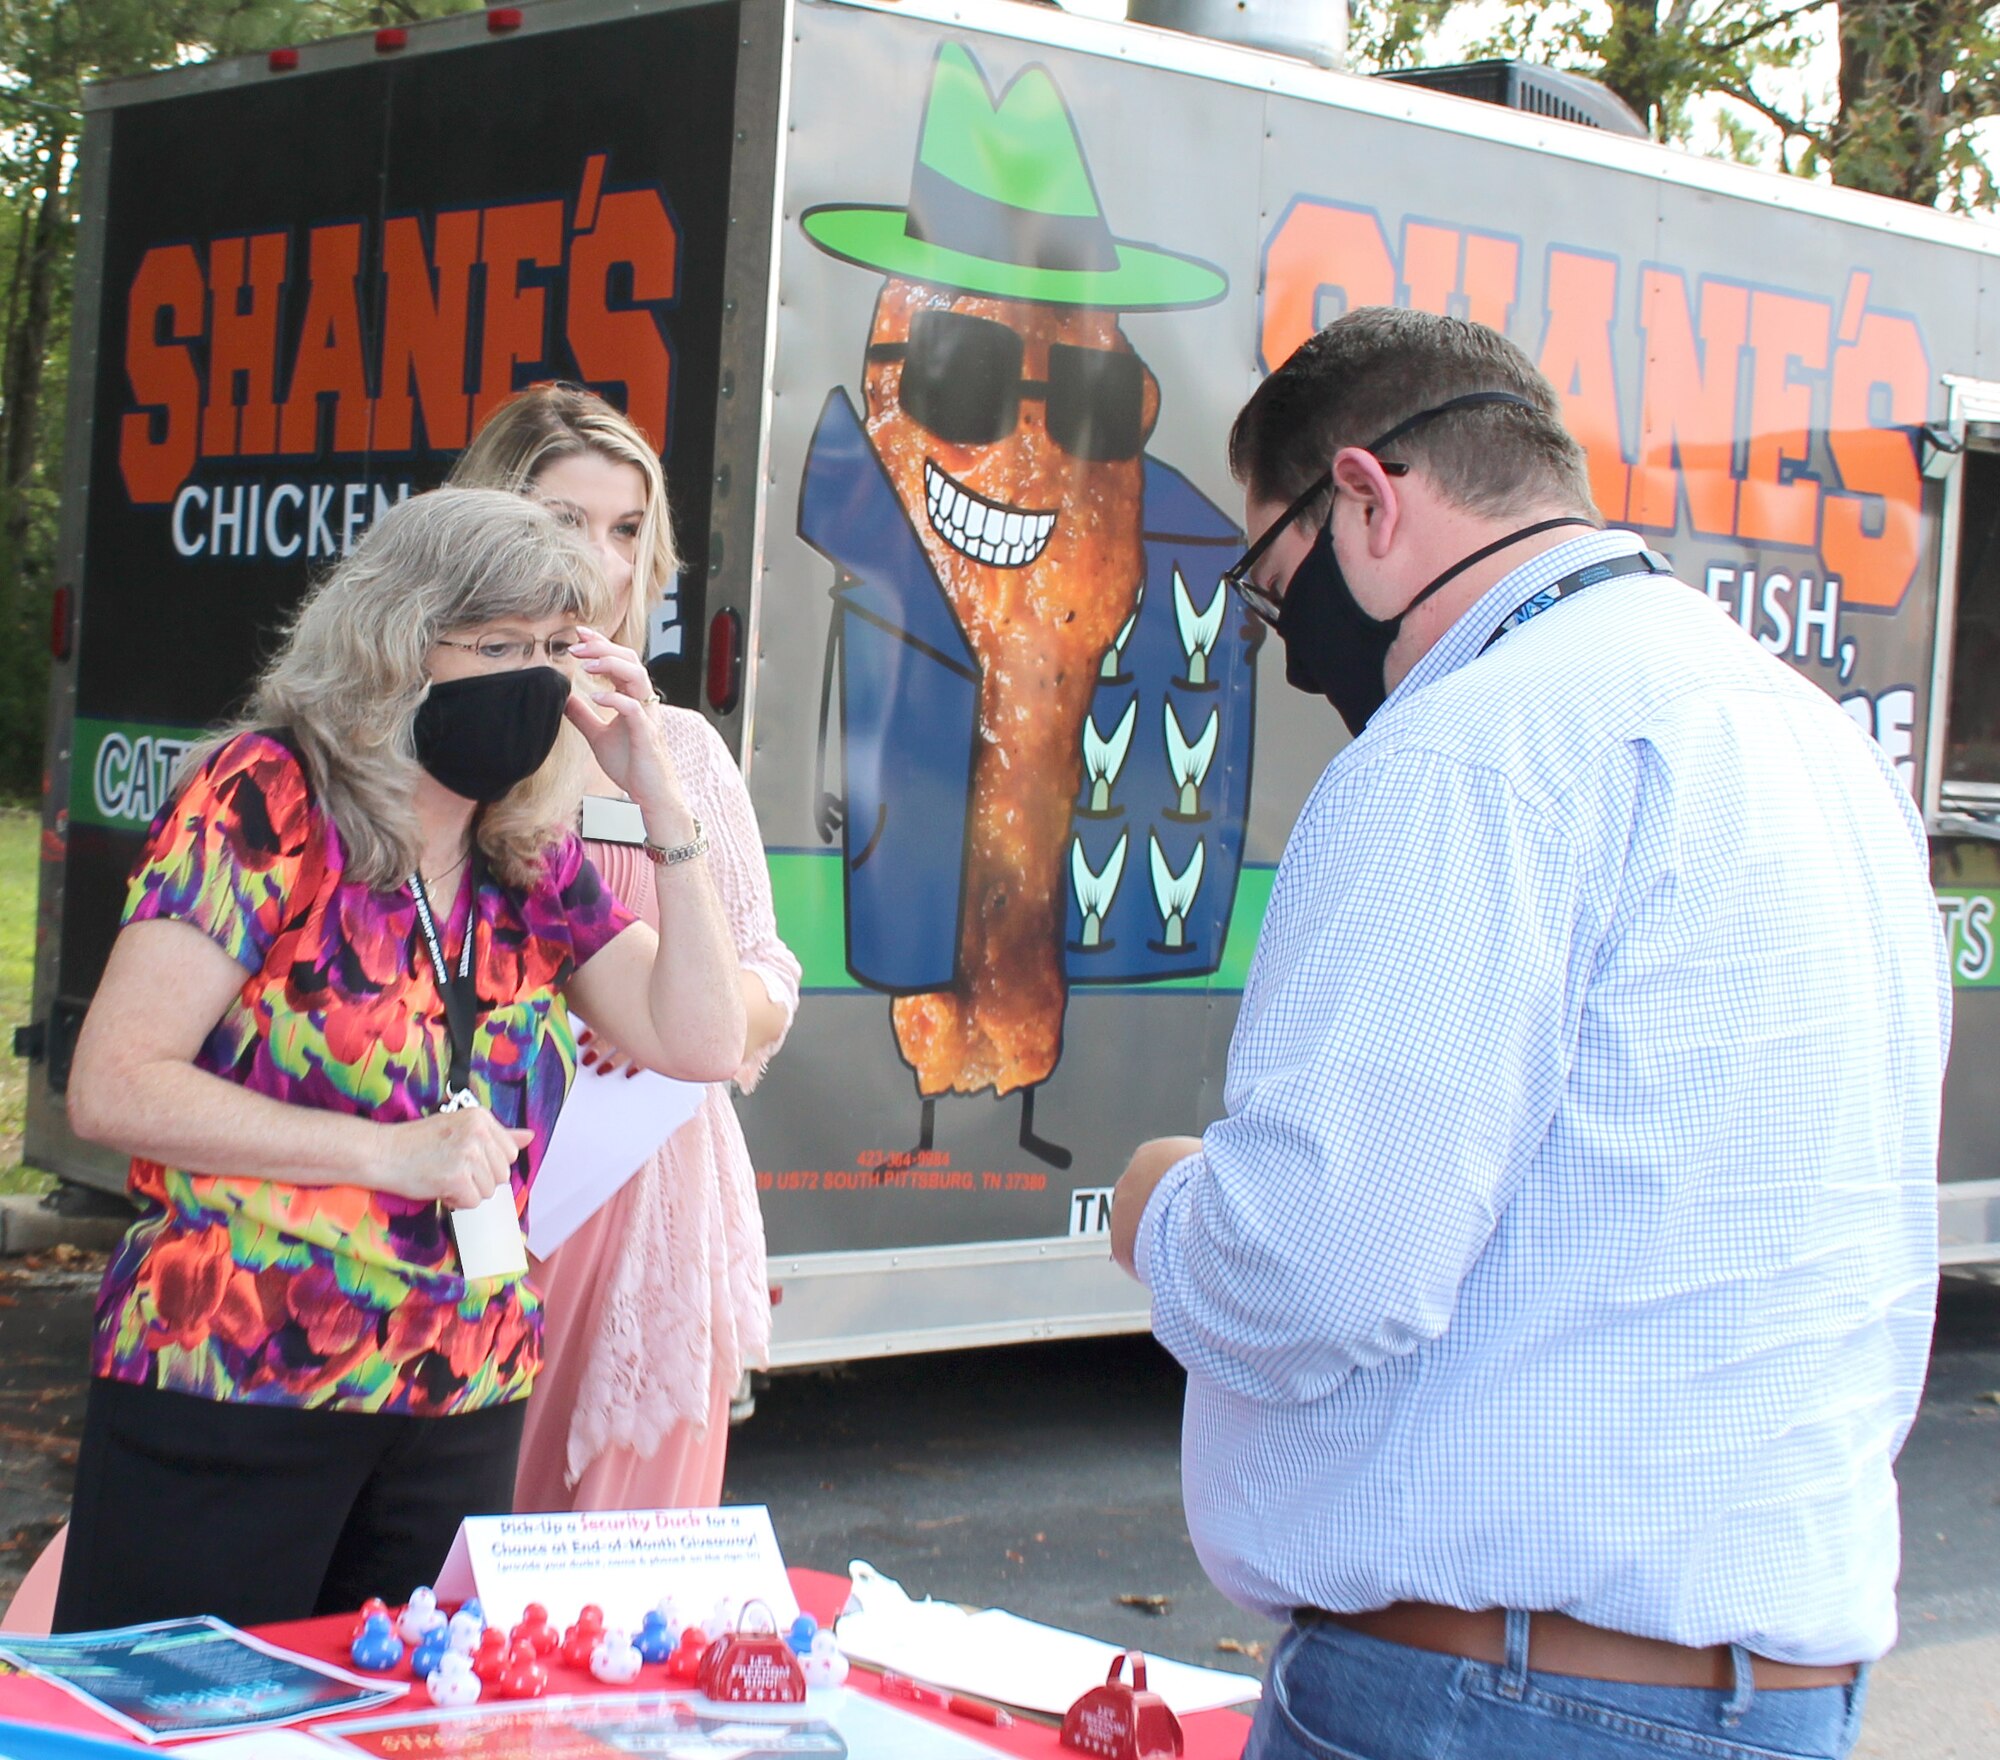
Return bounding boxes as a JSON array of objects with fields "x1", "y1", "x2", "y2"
[{"x1": 92, "y1": 734, "x2": 634, "y2": 1416}]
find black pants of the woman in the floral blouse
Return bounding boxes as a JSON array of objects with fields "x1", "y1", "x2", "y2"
[{"x1": 56, "y1": 1380, "x2": 526, "y2": 1632}]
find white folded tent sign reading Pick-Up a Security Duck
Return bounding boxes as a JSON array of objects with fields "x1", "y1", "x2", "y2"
[{"x1": 436, "y1": 1504, "x2": 798, "y2": 1632}]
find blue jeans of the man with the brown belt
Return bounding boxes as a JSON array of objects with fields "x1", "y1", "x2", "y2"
[{"x1": 1244, "y1": 1614, "x2": 1868, "y2": 1760}]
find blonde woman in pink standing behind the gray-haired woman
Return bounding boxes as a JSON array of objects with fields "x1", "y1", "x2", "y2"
[{"x1": 452, "y1": 386, "x2": 798, "y2": 1510}]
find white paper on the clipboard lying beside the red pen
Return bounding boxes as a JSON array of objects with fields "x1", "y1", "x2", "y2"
[{"x1": 834, "y1": 1560, "x2": 1262, "y2": 1716}]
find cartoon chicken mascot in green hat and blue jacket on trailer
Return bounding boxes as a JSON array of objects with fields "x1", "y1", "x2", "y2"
[{"x1": 800, "y1": 44, "x2": 1254, "y2": 1168}]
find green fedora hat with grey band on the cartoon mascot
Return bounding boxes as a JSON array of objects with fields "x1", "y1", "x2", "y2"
[{"x1": 800, "y1": 42, "x2": 1230, "y2": 312}]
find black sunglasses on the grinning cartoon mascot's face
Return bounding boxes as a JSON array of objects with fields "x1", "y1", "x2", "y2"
[{"x1": 868, "y1": 308, "x2": 1146, "y2": 462}]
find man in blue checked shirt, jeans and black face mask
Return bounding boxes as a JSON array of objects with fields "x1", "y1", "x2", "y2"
[{"x1": 1112, "y1": 310, "x2": 1950, "y2": 1760}]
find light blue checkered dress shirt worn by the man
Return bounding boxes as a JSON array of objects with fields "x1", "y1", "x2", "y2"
[{"x1": 1138, "y1": 532, "x2": 1950, "y2": 1662}]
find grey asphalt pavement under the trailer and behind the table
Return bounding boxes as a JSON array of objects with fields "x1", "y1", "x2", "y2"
[{"x1": 0, "y1": 1254, "x2": 2000, "y2": 1760}]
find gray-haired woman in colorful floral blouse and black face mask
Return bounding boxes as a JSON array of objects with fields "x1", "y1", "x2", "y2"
[{"x1": 56, "y1": 490, "x2": 744, "y2": 1630}]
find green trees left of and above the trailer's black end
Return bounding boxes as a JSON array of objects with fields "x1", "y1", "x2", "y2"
[{"x1": 0, "y1": 0, "x2": 478, "y2": 798}]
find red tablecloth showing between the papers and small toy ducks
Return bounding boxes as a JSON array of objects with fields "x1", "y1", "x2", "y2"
[{"x1": 0, "y1": 1570, "x2": 1250, "y2": 1760}]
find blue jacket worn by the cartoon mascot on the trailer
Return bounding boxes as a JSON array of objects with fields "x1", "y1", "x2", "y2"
[{"x1": 798, "y1": 390, "x2": 1256, "y2": 992}]
